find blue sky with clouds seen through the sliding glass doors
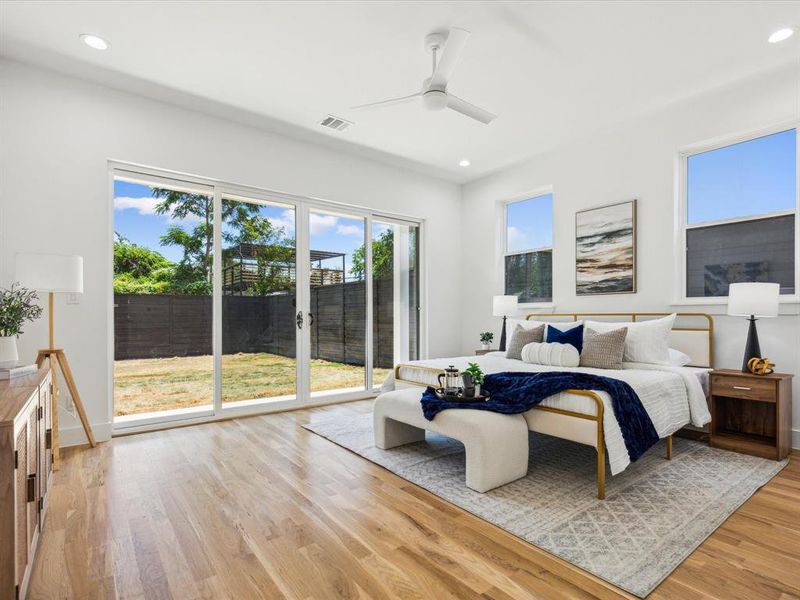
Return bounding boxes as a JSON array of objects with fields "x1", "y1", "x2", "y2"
[{"x1": 114, "y1": 180, "x2": 387, "y2": 278}]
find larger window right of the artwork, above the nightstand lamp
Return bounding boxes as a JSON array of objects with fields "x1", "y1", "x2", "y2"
[{"x1": 683, "y1": 129, "x2": 797, "y2": 298}]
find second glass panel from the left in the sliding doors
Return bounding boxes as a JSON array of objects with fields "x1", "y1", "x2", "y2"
[{"x1": 221, "y1": 195, "x2": 298, "y2": 406}]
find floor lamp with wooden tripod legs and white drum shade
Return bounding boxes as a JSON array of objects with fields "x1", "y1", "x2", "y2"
[{"x1": 15, "y1": 253, "x2": 97, "y2": 469}]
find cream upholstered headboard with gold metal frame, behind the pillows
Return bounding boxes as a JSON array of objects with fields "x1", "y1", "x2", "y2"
[{"x1": 525, "y1": 312, "x2": 714, "y2": 368}]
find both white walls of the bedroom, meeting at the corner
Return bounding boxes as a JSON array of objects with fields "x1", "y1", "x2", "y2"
[{"x1": 0, "y1": 60, "x2": 800, "y2": 446}]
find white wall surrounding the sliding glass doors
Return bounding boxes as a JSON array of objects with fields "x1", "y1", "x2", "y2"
[{"x1": 0, "y1": 60, "x2": 461, "y2": 442}]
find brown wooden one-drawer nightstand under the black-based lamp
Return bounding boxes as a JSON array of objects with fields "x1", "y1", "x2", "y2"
[{"x1": 710, "y1": 369, "x2": 793, "y2": 460}]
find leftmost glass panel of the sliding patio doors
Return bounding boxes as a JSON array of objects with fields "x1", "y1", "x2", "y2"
[{"x1": 113, "y1": 178, "x2": 214, "y2": 423}]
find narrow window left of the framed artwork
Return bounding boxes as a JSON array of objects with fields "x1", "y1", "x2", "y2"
[{"x1": 504, "y1": 194, "x2": 553, "y2": 303}]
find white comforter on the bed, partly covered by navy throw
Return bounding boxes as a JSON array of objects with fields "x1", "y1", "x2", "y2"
[{"x1": 381, "y1": 352, "x2": 711, "y2": 475}]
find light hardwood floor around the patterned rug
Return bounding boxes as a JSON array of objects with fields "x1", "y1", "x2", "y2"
[{"x1": 30, "y1": 401, "x2": 800, "y2": 600}]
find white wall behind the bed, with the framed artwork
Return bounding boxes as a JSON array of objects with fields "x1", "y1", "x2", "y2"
[{"x1": 461, "y1": 71, "x2": 800, "y2": 447}]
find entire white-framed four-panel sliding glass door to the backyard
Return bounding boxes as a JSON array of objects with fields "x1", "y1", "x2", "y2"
[{"x1": 112, "y1": 168, "x2": 421, "y2": 429}]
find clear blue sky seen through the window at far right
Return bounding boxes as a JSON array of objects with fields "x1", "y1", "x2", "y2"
[{"x1": 687, "y1": 129, "x2": 797, "y2": 224}]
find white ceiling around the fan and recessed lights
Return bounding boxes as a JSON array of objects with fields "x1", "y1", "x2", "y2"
[{"x1": 0, "y1": 0, "x2": 800, "y2": 181}]
